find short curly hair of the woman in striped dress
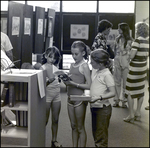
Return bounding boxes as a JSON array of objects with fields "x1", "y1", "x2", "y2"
[{"x1": 135, "y1": 22, "x2": 149, "y2": 38}]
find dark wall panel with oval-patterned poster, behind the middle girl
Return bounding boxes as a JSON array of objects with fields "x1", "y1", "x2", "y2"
[{"x1": 63, "y1": 14, "x2": 95, "y2": 53}]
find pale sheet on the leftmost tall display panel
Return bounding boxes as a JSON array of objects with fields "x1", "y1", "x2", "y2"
[{"x1": 12, "y1": 16, "x2": 20, "y2": 35}]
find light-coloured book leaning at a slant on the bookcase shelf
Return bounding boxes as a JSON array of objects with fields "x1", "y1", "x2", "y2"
[{"x1": 5, "y1": 109, "x2": 16, "y2": 125}]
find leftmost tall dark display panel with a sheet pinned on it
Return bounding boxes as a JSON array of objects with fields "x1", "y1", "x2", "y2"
[{"x1": 7, "y1": 1, "x2": 24, "y2": 68}]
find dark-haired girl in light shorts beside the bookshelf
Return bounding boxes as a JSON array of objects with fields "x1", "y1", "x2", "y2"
[{"x1": 40, "y1": 46, "x2": 62, "y2": 147}]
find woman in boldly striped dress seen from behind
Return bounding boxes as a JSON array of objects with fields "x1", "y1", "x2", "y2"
[{"x1": 123, "y1": 22, "x2": 149, "y2": 123}]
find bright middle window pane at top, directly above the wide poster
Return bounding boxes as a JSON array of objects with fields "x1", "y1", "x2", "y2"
[{"x1": 62, "y1": 1, "x2": 97, "y2": 13}]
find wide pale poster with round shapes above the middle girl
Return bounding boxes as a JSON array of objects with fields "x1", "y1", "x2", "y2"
[{"x1": 70, "y1": 24, "x2": 89, "y2": 40}]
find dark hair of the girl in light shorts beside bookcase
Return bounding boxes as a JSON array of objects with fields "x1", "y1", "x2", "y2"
[{"x1": 42, "y1": 46, "x2": 61, "y2": 66}]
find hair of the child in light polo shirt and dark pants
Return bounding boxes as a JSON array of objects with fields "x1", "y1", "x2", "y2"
[{"x1": 91, "y1": 48, "x2": 110, "y2": 67}]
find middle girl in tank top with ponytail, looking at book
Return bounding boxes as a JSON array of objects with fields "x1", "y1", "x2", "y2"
[{"x1": 64, "y1": 41, "x2": 91, "y2": 147}]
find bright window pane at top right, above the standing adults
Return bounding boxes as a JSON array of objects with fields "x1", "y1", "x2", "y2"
[{"x1": 99, "y1": 1, "x2": 135, "y2": 13}]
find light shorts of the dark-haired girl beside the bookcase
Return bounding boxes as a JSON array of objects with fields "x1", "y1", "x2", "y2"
[{"x1": 46, "y1": 85, "x2": 61, "y2": 102}]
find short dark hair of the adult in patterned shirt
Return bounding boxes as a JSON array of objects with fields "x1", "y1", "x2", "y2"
[{"x1": 97, "y1": 19, "x2": 113, "y2": 33}]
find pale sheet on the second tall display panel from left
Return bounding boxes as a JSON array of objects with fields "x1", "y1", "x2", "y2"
[{"x1": 24, "y1": 18, "x2": 31, "y2": 35}]
